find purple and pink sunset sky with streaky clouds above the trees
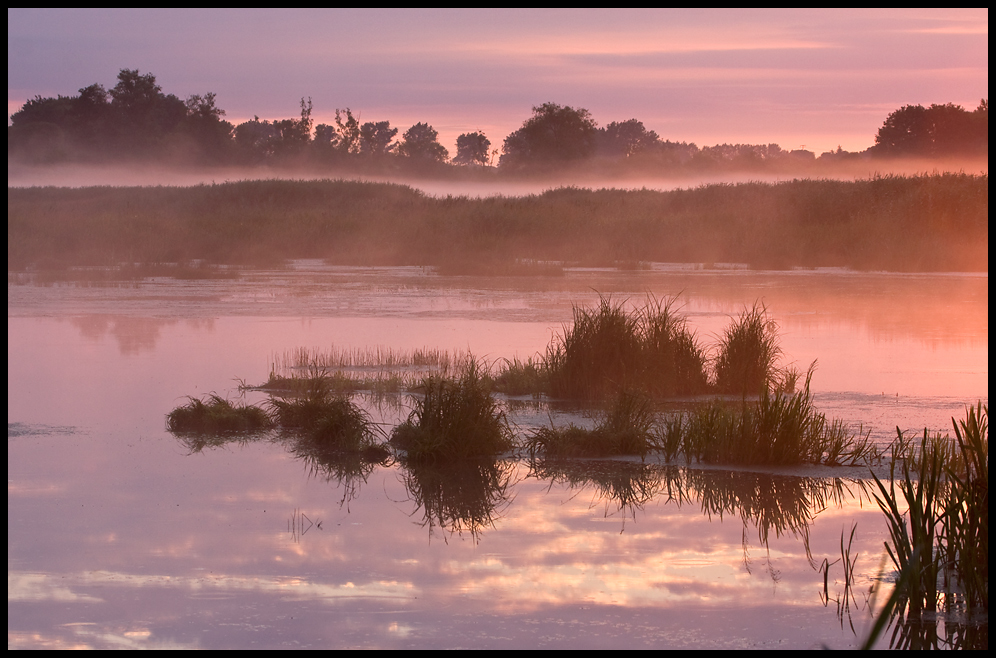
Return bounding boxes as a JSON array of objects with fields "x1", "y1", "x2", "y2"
[{"x1": 7, "y1": 8, "x2": 989, "y2": 154}]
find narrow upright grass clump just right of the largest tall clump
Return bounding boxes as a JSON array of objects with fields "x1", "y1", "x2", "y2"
[{"x1": 715, "y1": 302, "x2": 781, "y2": 395}]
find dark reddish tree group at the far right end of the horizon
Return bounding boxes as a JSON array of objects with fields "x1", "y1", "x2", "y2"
[{"x1": 873, "y1": 99, "x2": 989, "y2": 157}]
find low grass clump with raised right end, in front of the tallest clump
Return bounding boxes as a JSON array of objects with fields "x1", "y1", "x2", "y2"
[{"x1": 526, "y1": 394, "x2": 658, "y2": 459}]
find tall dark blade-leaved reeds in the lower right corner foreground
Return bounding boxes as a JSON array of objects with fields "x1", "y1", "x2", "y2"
[{"x1": 875, "y1": 404, "x2": 989, "y2": 615}]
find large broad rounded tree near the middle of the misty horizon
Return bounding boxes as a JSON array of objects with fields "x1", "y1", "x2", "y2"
[{"x1": 500, "y1": 103, "x2": 597, "y2": 166}]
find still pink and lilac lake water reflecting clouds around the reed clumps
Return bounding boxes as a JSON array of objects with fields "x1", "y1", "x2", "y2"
[{"x1": 7, "y1": 262, "x2": 989, "y2": 648}]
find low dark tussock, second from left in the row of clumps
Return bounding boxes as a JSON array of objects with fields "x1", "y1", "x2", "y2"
[{"x1": 270, "y1": 372, "x2": 376, "y2": 452}]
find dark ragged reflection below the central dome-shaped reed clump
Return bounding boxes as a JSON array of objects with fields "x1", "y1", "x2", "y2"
[{"x1": 404, "y1": 459, "x2": 514, "y2": 541}]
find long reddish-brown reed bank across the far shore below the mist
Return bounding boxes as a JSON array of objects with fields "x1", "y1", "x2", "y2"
[{"x1": 7, "y1": 174, "x2": 989, "y2": 273}]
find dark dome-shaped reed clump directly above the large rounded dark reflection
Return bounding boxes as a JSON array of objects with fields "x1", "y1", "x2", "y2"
[{"x1": 391, "y1": 359, "x2": 514, "y2": 462}]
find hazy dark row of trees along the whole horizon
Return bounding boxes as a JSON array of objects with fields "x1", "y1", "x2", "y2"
[{"x1": 7, "y1": 69, "x2": 989, "y2": 172}]
